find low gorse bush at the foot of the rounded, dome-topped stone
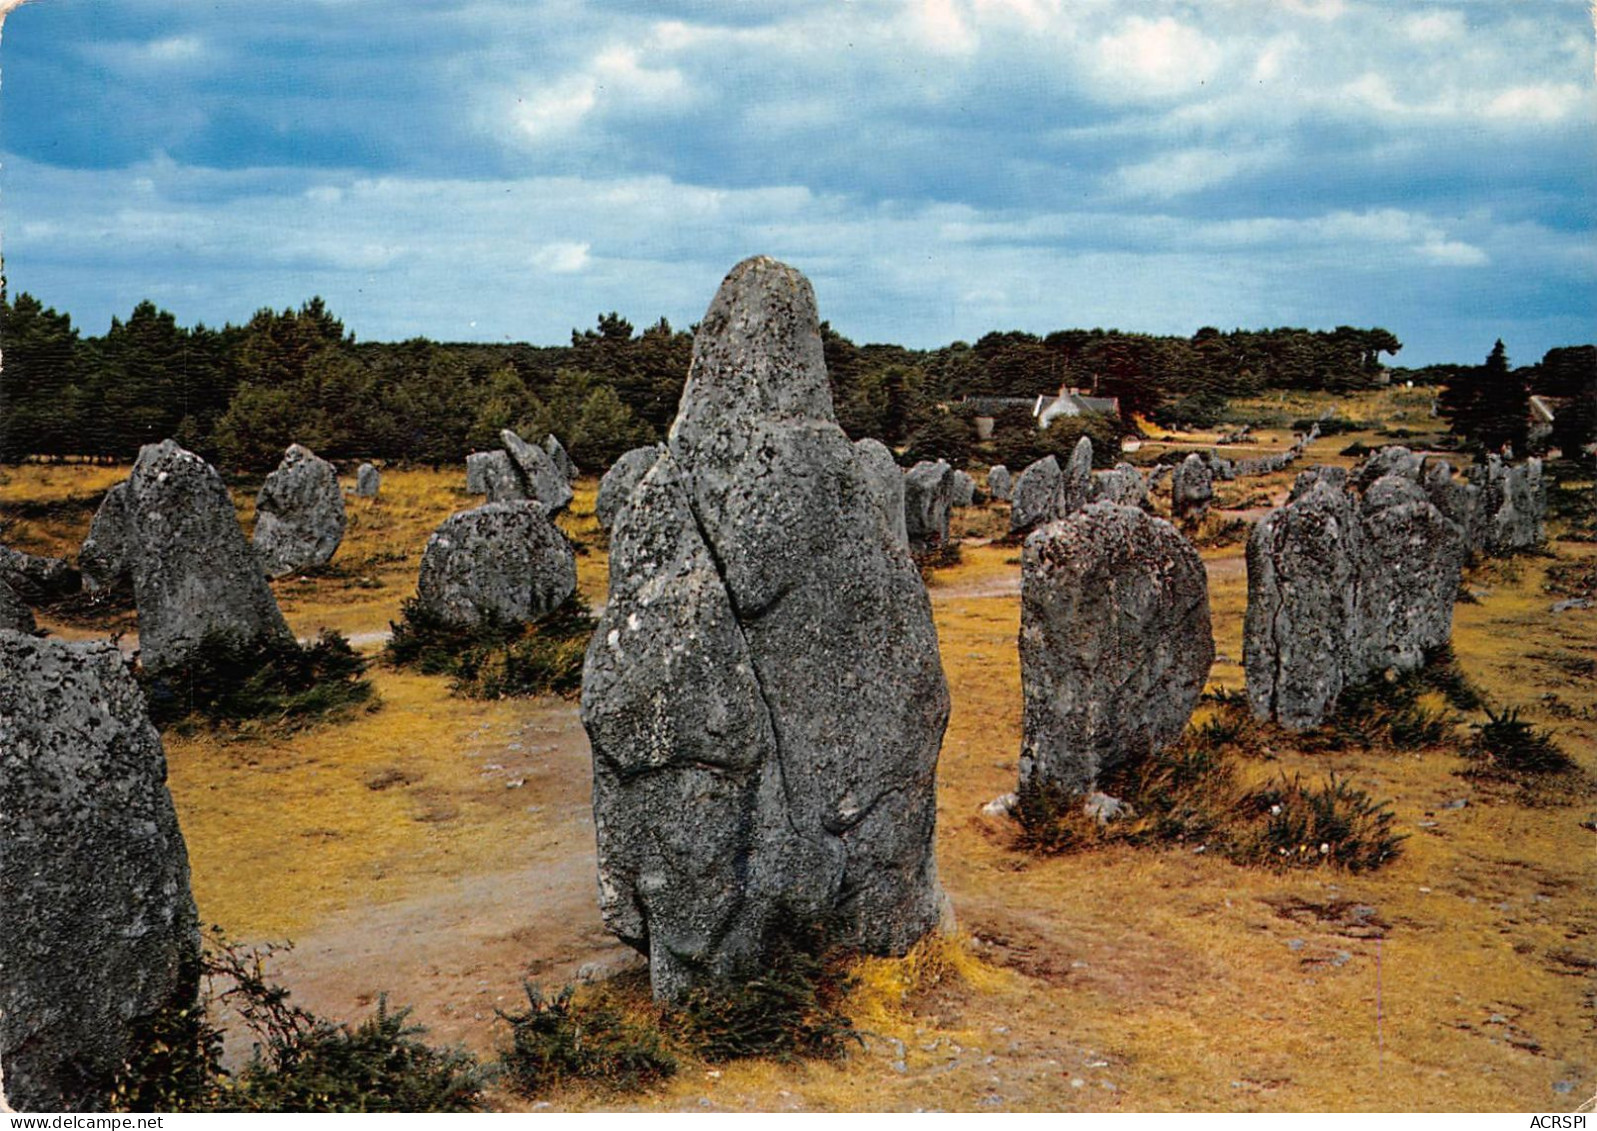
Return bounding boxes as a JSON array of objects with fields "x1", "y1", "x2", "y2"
[{"x1": 383, "y1": 594, "x2": 596, "y2": 700}]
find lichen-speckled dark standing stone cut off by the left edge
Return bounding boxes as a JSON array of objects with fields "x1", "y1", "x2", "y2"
[{"x1": 0, "y1": 635, "x2": 201, "y2": 1112}]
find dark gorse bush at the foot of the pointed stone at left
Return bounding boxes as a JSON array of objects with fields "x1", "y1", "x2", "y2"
[{"x1": 139, "y1": 629, "x2": 372, "y2": 727}]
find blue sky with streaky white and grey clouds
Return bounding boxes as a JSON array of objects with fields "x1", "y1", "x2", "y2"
[{"x1": 0, "y1": 0, "x2": 1597, "y2": 364}]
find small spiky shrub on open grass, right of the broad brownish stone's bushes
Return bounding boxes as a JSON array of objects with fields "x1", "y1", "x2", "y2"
[{"x1": 1230, "y1": 775, "x2": 1404, "y2": 872}]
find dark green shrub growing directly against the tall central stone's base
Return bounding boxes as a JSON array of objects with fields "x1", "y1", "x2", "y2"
[{"x1": 669, "y1": 922, "x2": 859, "y2": 1062}]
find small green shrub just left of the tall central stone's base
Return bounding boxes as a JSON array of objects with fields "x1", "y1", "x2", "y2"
[{"x1": 497, "y1": 984, "x2": 677, "y2": 1097}]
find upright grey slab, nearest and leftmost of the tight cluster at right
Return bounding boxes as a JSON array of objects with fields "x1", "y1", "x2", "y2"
[{"x1": 1242, "y1": 468, "x2": 1362, "y2": 730}]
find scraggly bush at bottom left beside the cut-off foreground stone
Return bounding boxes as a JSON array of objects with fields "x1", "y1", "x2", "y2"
[{"x1": 110, "y1": 931, "x2": 482, "y2": 1112}]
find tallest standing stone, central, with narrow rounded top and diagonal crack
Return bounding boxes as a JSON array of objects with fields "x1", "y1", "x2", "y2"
[{"x1": 583, "y1": 259, "x2": 949, "y2": 1000}]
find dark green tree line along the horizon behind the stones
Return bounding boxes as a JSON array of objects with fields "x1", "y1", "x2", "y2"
[{"x1": 0, "y1": 292, "x2": 1584, "y2": 471}]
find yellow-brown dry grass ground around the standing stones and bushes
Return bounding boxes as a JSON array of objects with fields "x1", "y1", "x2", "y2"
[{"x1": 0, "y1": 408, "x2": 1597, "y2": 1110}]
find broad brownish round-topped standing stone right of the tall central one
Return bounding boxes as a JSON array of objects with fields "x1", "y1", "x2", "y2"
[{"x1": 1020, "y1": 503, "x2": 1214, "y2": 794}]
